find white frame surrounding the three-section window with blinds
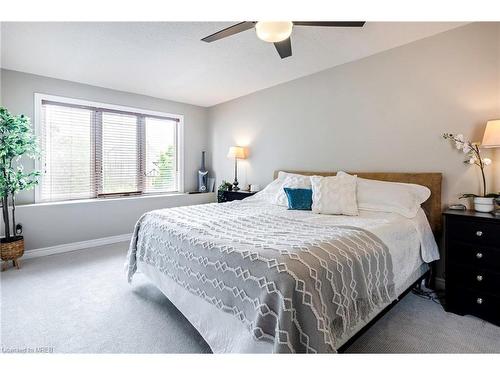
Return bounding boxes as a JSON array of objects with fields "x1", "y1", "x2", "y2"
[{"x1": 33, "y1": 93, "x2": 185, "y2": 204}]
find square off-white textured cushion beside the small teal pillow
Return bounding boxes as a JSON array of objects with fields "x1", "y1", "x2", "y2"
[{"x1": 311, "y1": 174, "x2": 358, "y2": 216}]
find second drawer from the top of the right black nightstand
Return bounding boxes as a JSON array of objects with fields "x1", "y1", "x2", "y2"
[{"x1": 446, "y1": 241, "x2": 500, "y2": 270}]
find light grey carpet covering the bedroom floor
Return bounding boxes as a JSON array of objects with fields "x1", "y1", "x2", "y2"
[{"x1": 0, "y1": 243, "x2": 500, "y2": 353}]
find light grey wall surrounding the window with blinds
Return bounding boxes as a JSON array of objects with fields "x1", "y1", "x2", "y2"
[{"x1": 0, "y1": 69, "x2": 215, "y2": 250}]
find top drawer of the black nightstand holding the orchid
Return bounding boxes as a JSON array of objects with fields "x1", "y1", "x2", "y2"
[{"x1": 446, "y1": 217, "x2": 500, "y2": 246}]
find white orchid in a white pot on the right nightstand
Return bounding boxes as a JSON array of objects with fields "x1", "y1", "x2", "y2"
[{"x1": 443, "y1": 133, "x2": 500, "y2": 212}]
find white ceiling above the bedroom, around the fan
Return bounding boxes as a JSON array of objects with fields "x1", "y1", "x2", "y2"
[{"x1": 1, "y1": 22, "x2": 463, "y2": 106}]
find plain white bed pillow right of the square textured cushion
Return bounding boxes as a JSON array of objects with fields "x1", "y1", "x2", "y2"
[{"x1": 337, "y1": 172, "x2": 431, "y2": 219}]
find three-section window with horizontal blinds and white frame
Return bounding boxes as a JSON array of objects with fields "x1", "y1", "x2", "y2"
[{"x1": 36, "y1": 94, "x2": 182, "y2": 202}]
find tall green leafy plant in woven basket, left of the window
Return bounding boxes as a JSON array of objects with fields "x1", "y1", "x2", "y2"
[{"x1": 0, "y1": 107, "x2": 40, "y2": 268}]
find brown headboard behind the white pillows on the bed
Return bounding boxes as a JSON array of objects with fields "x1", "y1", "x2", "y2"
[{"x1": 274, "y1": 171, "x2": 442, "y2": 234}]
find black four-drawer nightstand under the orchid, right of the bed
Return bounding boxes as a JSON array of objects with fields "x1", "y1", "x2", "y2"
[{"x1": 443, "y1": 210, "x2": 500, "y2": 325}]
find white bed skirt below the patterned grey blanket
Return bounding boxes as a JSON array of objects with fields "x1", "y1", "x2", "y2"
[{"x1": 137, "y1": 262, "x2": 429, "y2": 353}]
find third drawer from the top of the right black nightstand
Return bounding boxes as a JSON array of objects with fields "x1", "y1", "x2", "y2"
[{"x1": 446, "y1": 267, "x2": 500, "y2": 298}]
